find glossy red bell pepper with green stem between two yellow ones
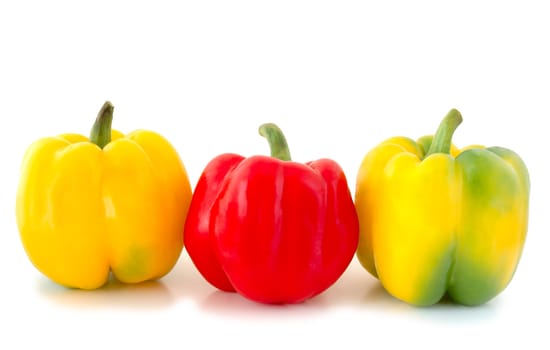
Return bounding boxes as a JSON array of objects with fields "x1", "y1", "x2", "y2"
[{"x1": 184, "y1": 124, "x2": 359, "y2": 304}]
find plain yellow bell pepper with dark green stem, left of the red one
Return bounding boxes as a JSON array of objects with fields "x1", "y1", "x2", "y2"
[{"x1": 16, "y1": 102, "x2": 191, "y2": 289}]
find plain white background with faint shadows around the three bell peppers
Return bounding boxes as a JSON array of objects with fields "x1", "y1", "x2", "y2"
[{"x1": 0, "y1": 0, "x2": 550, "y2": 349}]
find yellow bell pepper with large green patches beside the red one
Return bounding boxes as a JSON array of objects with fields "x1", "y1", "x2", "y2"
[{"x1": 355, "y1": 110, "x2": 529, "y2": 305}]
